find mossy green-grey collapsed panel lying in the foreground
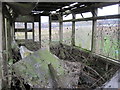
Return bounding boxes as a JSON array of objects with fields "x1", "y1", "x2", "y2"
[{"x1": 13, "y1": 49, "x2": 81, "y2": 88}]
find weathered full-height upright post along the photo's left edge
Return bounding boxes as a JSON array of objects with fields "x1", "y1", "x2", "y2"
[{"x1": 0, "y1": 2, "x2": 8, "y2": 90}]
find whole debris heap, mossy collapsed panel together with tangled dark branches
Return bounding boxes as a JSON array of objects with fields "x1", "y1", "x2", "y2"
[{"x1": 10, "y1": 41, "x2": 119, "y2": 89}]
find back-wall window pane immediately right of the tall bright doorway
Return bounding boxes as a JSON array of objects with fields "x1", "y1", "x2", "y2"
[{"x1": 52, "y1": 22, "x2": 59, "y2": 41}]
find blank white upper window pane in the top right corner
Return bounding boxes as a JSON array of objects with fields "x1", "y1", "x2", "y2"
[{"x1": 98, "y1": 4, "x2": 119, "y2": 16}]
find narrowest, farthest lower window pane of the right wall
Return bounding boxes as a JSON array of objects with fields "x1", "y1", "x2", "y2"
[{"x1": 63, "y1": 22, "x2": 72, "y2": 45}]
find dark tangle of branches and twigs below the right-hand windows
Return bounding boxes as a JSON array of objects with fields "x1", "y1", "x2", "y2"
[{"x1": 50, "y1": 43, "x2": 120, "y2": 89}]
